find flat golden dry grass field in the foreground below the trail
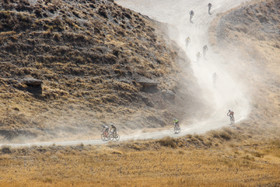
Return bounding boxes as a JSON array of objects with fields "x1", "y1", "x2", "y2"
[{"x1": 0, "y1": 139, "x2": 280, "y2": 186}]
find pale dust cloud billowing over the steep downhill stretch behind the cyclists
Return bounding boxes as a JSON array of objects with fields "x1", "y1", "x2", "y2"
[{"x1": 116, "y1": 0, "x2": 250, "y2": 131}]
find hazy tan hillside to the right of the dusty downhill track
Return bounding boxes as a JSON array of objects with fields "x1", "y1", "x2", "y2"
[{"x1": 210, "y1": 0, "x2": 280, "y2": 137}]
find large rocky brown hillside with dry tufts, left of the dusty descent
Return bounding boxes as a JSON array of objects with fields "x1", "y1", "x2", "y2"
[{"x1": 0, "y1": 0, "x2": 199, "y2": 140}]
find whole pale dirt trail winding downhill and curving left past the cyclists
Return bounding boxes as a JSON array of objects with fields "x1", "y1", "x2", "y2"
[{"x1": 0, "y1": 0, "x2": 250, "y2": 147}]
